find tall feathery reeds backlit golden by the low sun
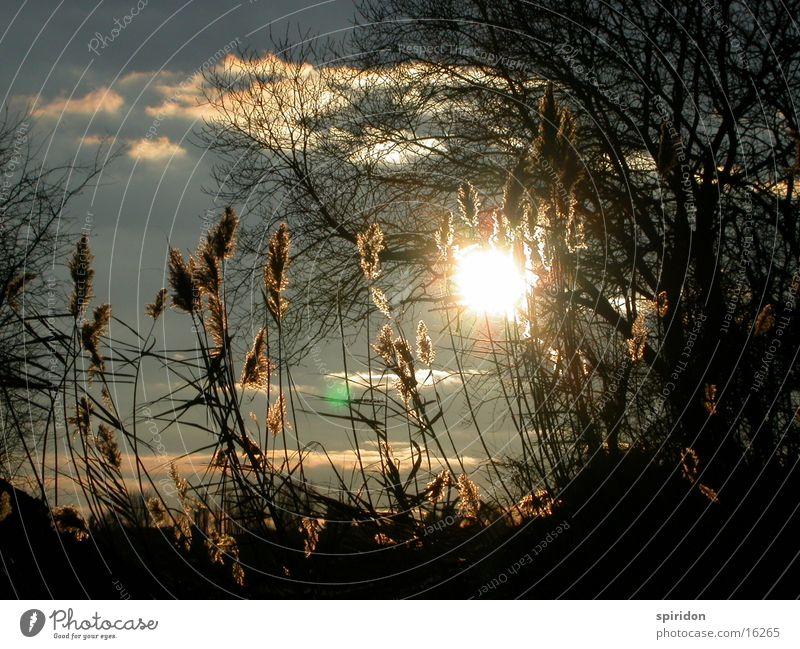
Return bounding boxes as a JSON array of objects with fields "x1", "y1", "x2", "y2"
[{"x1": 7, "y1": 86, "x2": 692, "y2": 585}]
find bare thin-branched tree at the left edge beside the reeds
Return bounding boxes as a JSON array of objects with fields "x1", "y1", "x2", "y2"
[{"x1": 0, "y1": 111, "x2": 106, "y2": 477}]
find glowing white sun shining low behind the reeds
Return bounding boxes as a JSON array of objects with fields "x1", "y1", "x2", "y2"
[{"x1": 455, "y1": 246, "x2": 527, "y2": 317}]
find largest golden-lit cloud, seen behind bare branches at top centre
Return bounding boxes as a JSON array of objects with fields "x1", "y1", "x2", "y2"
[{"x1": 136, "y1": 49, "x2": 432, "y2": 165}]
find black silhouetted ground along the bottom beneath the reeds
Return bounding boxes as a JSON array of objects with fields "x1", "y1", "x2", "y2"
[{"x1": 0, "y1": 450, "x2": 800, "y2": 599}]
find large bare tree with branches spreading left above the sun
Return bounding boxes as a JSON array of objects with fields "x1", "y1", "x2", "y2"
[{"x1": 198, "y1": 0, "x2": 800, "y2": 475}]
